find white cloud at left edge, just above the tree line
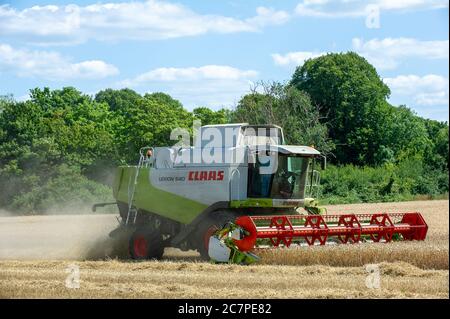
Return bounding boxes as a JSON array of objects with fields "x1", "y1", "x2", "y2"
[{"x1": 0, "y1": 44, "x2": 119, "y2": 80}]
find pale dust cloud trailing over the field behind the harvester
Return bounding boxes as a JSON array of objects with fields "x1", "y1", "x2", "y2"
[{"x1": 0, "y1": 211, "x2": 126, "y2": 260}]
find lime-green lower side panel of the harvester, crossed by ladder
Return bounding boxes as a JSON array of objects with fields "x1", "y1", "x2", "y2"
[{"x1": 113, "y1": 166, "x2": 208, "y2": 224}]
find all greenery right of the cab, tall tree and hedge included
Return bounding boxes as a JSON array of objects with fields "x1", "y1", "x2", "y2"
[{"x1": 291, "y1": 52, "x2": 449, "y2": 203}]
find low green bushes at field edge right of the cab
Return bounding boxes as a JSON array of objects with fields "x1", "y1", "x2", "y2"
[{"x1": 321, "y1": 158, "x2": 448, "y2": 204}]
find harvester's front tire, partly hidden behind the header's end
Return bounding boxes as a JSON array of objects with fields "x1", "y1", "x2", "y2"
[{"x1": 196, "y1": 211, "x2": 237, "y2": 260}]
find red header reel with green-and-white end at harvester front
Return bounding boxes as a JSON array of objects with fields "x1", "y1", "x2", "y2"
[{"x1": 209, "y1": 212, "x2": 428, "y2": 264}]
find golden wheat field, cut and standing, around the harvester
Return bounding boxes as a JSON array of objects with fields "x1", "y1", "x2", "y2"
[{"x1": 0, "y1": 200, "x2": 449, "y2": 298}]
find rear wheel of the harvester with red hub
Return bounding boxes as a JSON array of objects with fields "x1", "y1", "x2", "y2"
[{"x1": 129, "y1": 227, "x2": 164, "y2": 260}]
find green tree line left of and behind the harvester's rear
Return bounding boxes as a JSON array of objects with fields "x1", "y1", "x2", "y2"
[{"x1": 0, "y1": 87, "x2": 197, "y2": 212}]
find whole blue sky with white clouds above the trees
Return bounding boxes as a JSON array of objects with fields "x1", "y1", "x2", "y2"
[{"x1": 0, "y1": 0, "x2": 449, "y2": 121}]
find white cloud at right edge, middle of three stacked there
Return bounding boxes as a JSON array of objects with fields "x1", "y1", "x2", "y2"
[{"x1": 352, "y1": 38, "x2": 449, "y2": 70}]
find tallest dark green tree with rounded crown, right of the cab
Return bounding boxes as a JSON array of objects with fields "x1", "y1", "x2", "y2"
[{"x1": 291, "y1": 52, "x2": 390, "y2": 164}]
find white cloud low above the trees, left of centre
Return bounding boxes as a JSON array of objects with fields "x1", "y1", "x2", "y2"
[{"x1": 117, "y1": 65, "x2": 258, "y2": 109}]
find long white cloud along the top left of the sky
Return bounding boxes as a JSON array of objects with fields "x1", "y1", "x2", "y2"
[{"x1": 0, "y1": 0, "x2": 289, "y2": 44}]
